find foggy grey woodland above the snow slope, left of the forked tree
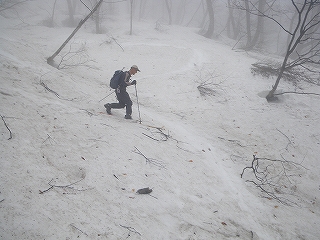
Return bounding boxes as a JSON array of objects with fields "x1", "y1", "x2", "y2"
[{"x1": 0, "y1": 0, "x2": 304, "y2": 55}]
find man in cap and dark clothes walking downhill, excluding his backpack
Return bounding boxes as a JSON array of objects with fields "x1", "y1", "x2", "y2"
[{"x1": 104, "y1": 65, "x2": 140, "y2": 119}]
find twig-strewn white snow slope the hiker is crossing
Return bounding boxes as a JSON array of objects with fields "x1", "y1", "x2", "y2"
[{"x1": 0, "y1": 4, "x2": 320, "y2": 239}]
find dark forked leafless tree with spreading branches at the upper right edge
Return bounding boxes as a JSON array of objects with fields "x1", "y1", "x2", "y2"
[{"x1": 260, "y1": 0, "x2": 320, "y2": 101}]
